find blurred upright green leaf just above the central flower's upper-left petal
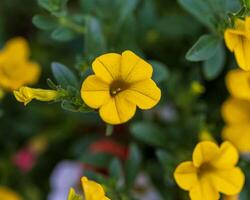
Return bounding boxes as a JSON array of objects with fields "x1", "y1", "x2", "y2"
[{"x1": 85, "y1": 17, "x2": 106, "y2": 58}]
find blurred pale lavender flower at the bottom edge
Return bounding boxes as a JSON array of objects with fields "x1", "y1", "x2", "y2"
[{"x1": 48, "y1": 161, "x2": 83, "y2": 200}]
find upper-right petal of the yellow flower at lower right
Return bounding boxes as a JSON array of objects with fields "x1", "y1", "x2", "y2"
[{"x1": 212, "y1": 142, "x2": 239, "y2": 169}]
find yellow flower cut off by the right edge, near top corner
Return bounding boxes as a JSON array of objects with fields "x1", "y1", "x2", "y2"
[{"x1": 224, "y1": 17, "x2": 250, "y2": 71}]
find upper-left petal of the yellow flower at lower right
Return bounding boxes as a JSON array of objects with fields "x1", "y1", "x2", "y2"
[{"x1": 193, "y1": 141, "x2": 220, "y2": 167}]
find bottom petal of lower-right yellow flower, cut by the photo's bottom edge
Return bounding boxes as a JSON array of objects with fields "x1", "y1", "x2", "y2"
[{"x1": 189, "y1": 178, "x2": 220, "y2": 200}]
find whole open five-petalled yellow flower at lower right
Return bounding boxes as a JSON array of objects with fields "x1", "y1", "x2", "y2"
[{"x1": 174, "y1": 141, "x2": 245, "y2": 200}]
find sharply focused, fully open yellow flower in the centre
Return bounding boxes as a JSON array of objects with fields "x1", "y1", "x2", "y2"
[{"x1": 81, "y1": 51, "x2": 161, "y2": 124}]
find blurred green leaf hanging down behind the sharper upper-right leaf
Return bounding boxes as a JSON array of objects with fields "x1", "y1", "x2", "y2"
[{"x1": 202, "y1": 44, "x2": 225, "y2": 80}]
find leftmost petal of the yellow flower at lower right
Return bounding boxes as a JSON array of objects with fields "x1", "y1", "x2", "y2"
[{"x1": 174, "y1": 161, "x2": 198, "y2": 190}]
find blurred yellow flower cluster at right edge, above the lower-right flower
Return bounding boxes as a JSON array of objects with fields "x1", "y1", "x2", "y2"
[{"x1": 222, "y1": 70, "x2": 250, "y2": 153}]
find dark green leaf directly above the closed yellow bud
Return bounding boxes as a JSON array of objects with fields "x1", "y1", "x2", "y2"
[{"x1": 51, "y1": 62, "x2": 79, "y2": 89}]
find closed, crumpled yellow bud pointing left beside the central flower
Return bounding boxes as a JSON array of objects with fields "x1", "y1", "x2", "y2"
[{"x1": 14, "y1": 87, "x2": 59, "y2": 105}]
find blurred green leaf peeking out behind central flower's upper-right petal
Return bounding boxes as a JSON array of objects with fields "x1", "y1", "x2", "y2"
[{"x1": 149, "y1": 60, "x2": 169, "y2": 83}]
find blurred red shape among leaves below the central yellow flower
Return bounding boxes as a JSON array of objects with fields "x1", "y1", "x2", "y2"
[{"x1": 89, "y1": 139, "x2": 128, "y2": 160}]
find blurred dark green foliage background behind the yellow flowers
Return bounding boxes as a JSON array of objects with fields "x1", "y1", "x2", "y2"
[{"x1": 0, "y1": 0, "x2": 250, "y2": 200}]
